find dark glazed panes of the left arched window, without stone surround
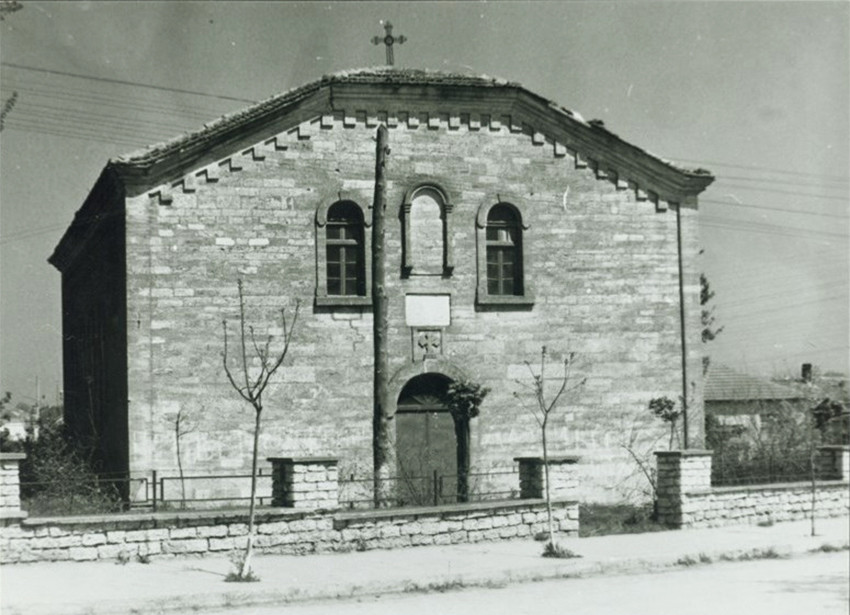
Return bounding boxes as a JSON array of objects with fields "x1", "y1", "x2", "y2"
[{"x1": 325, "y1": 201, "x2": 366, "y2": 297}]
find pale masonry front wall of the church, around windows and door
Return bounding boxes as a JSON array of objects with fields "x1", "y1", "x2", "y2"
[{"x1": 121, "y1": 113, "x2": 701, "y2": 500}]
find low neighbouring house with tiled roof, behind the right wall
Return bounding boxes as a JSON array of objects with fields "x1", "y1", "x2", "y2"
[{"x1": 704, "y1": 362, "x2": 805, "y2": 428}]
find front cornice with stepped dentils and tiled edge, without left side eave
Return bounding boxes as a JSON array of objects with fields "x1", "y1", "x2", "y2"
[{"x1": 110, "y1": 70, "x2": 714, "y2": 202}]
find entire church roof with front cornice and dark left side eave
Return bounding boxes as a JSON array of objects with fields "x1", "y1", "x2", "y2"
[{"x1": 48, "y1": 67, "x2": 714, "y2": 270}]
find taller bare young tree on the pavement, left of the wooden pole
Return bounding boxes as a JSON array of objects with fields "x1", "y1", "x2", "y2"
[{"x1": 221, "y1": 279, "x2": 300, "y2": 581}]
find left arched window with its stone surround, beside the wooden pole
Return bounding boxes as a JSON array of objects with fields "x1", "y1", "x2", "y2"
[{"x1": 316, "y1": 199, "x2": 371, "y2": 307}]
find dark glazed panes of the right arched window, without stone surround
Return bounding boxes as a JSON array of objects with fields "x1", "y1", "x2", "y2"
[{"x1": 486, "y1": 203, "x2": 523, "y2": 296}]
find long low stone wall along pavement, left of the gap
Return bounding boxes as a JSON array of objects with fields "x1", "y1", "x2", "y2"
[{"x1": 0, "y1": 499, "x2": 579, "y2": 564}]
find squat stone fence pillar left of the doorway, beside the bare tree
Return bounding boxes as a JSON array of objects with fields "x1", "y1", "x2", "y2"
[{"x1": 269, "y1": 457, "x2": 339, "y2": 509}]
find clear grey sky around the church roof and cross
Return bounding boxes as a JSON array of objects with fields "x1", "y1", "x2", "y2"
[{"x1": 0, "y1": 0, "x2": 850, "y2": 403}]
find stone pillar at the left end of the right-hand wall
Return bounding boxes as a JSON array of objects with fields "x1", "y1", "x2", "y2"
[{"x1": 655, "y1": 449, "x2": 712, "y2": 527}]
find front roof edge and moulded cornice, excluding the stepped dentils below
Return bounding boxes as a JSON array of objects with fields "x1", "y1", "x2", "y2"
[{"x1": 110, "y1": 67, "x2": 714, "y2": 200}]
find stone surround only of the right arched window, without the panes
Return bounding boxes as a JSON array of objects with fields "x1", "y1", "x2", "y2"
[{"x1": 475, "y1": 200, "x2": 534, "y2": 308}]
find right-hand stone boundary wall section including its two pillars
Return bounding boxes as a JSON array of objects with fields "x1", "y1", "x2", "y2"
[{"x1": 655, "y1": 447, "x2": 850, "y2": 528}]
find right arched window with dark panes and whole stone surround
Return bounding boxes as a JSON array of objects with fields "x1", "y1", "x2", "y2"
[{"x1": 475, "y1": 198, "x2": 534, "y2": 309}]
